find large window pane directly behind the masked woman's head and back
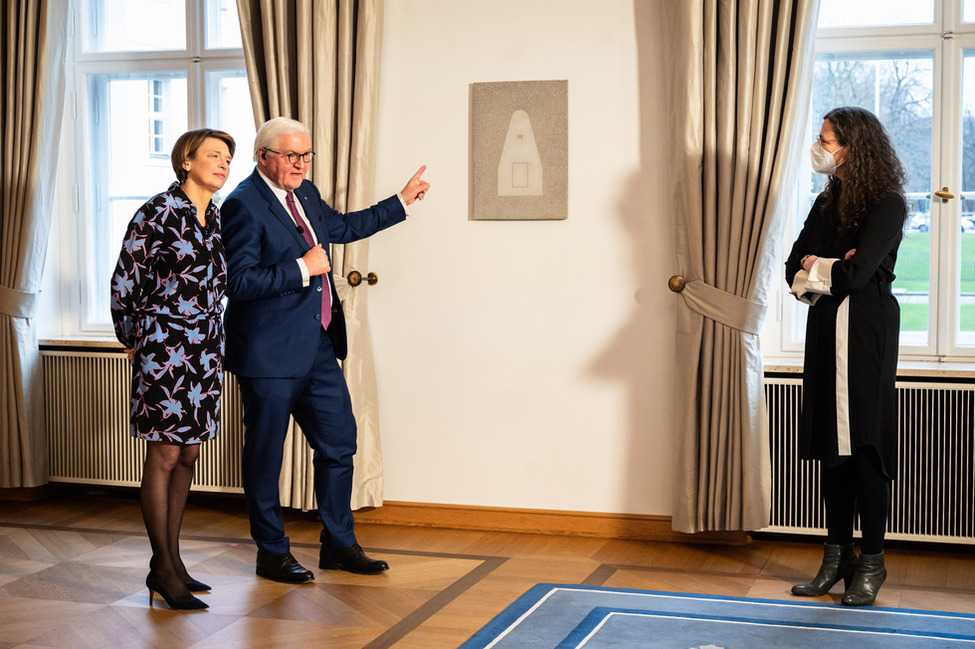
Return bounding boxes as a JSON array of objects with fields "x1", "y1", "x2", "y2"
[{"x1": 806, "y1": 52, "x2": 940, "y2": 345}]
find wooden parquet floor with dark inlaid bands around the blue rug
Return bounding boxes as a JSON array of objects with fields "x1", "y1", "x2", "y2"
[{"x1": 0, "y1": 486, "x2": 975, "y2": 649}]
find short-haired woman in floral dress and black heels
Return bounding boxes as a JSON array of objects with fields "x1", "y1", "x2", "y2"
[{"x1": 112, "y1": 129, "x2": 235, "y2": 610}]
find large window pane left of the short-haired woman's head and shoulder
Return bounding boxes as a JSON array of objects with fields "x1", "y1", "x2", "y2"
[{"x1": 87, "y1": 72, "x2": 187, "y2": 323}]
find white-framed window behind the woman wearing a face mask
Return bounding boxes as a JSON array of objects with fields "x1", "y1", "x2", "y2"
[{"x1": 780, "y1": 0, "x2": 975, "y2": 360}]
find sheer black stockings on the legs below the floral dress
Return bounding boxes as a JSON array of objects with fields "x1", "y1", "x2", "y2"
[{"x1": 141, "y1": 442, "x2": 200, "y2": 599}]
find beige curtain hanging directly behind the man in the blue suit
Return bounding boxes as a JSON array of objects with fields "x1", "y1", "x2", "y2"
[{"x1": 237, "y1": 0, "x2": 383, "y2": 509}]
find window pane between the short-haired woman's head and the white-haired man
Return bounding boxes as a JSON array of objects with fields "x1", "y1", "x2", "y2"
[{"x1": 207, "y1": 70, "x2": 256, "y2": 204}]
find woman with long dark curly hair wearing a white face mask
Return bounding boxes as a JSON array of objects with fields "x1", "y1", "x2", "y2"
[{"x1": 785, "y1": 107, "x2": 907, "y2": 606}]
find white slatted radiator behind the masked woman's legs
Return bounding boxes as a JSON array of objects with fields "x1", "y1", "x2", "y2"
[{"x1": 762, "y1": 377, "x2": 975, "y2": 544}]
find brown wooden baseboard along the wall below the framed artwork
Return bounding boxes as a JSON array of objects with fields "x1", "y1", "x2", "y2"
[{"x1": 355, "y1": 501, "x2": 751, "y2": 545}]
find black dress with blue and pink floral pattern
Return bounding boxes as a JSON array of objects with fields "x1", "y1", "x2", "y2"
[{"x1": 111, "y1": 182, "x2": 227, "y2": 444}]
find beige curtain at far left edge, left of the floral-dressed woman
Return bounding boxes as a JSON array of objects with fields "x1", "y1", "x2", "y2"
[{"x1": 0, "y1": 0, "x2": 69, "y2": 488}]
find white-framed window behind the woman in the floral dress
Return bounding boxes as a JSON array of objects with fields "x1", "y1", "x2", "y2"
[{"x1": 58, "y1": 0, "x2": 255, "y2": 334}]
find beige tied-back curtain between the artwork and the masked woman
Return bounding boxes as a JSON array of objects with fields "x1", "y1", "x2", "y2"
[{"x1": 670, "y1": 0, "x2": 819, "y2": 533}]
